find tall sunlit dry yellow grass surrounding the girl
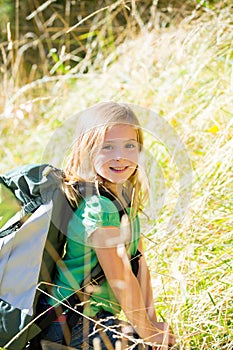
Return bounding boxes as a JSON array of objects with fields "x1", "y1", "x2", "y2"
[{"x1": 0, "y1": 1, "x2": 233, "y2": 350}]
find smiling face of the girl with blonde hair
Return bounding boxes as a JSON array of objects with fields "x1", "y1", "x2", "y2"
[{"x1": 94, "y1": 124, "x2": 140, "y2": 183}]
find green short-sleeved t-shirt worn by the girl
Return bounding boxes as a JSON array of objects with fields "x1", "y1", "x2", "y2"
[{"x1": 50, "y1": 195, "x2": 140, "y2": 317}]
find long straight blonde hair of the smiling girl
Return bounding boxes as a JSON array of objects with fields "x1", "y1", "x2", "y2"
[{"x1": 63, "y1": 102, "x2": 147, "y2": 213}]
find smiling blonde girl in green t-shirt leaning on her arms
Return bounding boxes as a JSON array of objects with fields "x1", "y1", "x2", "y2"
[{"x1": 42, "y1": 102, "x2": 175, "y2": 349}]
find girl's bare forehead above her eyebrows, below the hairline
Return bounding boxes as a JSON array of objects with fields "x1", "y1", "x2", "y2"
[{"x1": 104, "y1": 124, "x2": 137, "y2": 141}]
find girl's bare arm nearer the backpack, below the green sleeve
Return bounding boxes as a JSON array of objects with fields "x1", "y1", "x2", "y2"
[{"x1": 92, "y1": 227, "x2": 174, "y2": 344}]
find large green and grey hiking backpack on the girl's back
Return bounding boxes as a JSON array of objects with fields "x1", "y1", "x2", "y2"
[{"x1": 0, "y1": 164, "x2": 73, "y2": 350}]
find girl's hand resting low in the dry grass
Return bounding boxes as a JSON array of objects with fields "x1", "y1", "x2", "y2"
[{"x1": 150, "y1": 322, "x2": 176, "y2": 350}]
